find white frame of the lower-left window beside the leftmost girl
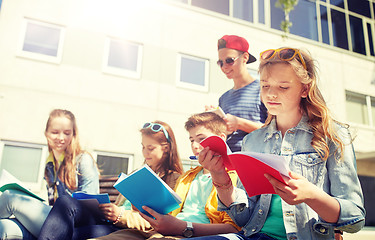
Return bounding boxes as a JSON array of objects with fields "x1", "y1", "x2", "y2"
[{"x1": 0, "y1": 140, "x2": 48, "y2": 192}]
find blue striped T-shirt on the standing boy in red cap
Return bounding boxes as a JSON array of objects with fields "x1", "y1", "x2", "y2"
[{"x1": 219, "y1": 79, "x2": 267, "y2": 152}]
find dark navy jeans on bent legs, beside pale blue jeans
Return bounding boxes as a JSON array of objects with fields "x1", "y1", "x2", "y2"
[{"x1": 38, "y1": 196, "x2": 120, "y2": 240}]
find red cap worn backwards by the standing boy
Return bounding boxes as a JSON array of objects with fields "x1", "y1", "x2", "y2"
[{"x1": 217, "y1": 35, "x2": 257, "y2": 63}]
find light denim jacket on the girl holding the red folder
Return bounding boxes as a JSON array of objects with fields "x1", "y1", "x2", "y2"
[{"x1": 219, "y1": 115, "x2": 365, "y2": 240}]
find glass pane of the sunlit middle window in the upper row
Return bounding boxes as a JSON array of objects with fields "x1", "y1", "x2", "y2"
[{"x1": 108, "y1": 40, "x2": 139, "y2": 71}]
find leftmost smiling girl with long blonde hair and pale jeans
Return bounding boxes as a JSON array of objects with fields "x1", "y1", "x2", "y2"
[{"x1": 0, "y1": 109, "x2": 99, "y2": 239}]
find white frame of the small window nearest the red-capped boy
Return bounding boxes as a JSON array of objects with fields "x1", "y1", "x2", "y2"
[{"x1": 176, "y1": 53, "x2": 209, "y2": 92}]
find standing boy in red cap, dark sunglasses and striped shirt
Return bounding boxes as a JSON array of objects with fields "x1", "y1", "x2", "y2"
[{"x1": 206, "y1": 35, "x2": 267, "y2": 152}]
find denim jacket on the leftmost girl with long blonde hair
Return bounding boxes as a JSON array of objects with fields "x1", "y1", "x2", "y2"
[{"x1": 45, "y1": 153, "x2": 99, "y2": 205}]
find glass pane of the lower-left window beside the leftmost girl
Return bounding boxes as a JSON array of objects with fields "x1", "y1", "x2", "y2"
[{"x1": 0, "y1": 144, "x2": 42, "y2": 182}]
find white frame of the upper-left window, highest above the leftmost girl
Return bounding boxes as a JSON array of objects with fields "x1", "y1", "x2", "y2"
[{"x1": 17, "y1": 18, "x2": 66, "y2": 64}]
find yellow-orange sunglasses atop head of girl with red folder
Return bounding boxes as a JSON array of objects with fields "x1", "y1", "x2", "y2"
[{"x1": 260, "y1": 48, "x2": 307, "y2": 70}]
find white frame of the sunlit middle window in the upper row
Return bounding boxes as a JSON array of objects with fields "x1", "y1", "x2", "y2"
[{"x1": 102, "y1": 37, "x2": 143, "y2": 79}]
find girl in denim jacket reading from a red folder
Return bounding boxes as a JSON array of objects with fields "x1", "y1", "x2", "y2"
[{"x1": 195, "y1": 48, "x2": 365, "y2": 240}]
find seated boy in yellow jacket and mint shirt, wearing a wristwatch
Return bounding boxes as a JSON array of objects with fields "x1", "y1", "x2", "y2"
[{"x1": 90, "y1": 112, "x2": 239, "y2": 240}]
